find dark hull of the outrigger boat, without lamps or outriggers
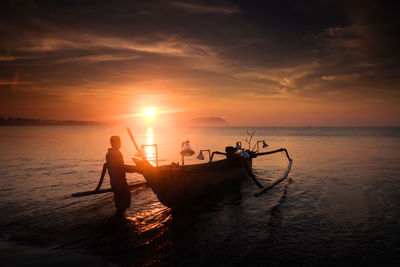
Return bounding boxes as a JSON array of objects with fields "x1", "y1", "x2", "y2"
[{"x1": 135, "y1": 158, "x2": 252, "y2": 209}]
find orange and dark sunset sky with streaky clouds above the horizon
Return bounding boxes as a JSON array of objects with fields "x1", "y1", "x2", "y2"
[{"x1": 0, "y1": 0, "x2": 400, "y2": 126}]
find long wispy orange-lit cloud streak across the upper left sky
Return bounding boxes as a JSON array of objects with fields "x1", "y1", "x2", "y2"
[{"x1": 0, "y1": 26, "x2": 223, "y2": 69}]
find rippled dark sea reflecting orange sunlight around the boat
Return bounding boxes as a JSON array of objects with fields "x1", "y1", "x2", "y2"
[{"x1": 0, "y1": 126, "x2": 400, "y2": 266}]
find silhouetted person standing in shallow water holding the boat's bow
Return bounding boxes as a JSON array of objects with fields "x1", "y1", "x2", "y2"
[{"x1": 95, "y1": 135, "x2": 137, "y2": 219}]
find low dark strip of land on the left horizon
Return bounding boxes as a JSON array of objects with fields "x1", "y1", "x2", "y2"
[{"x1": 0, "y1": 117, "x2": 104, "y2": 126}]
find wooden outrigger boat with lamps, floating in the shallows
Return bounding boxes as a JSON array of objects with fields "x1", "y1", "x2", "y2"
[{"x1": 72, "y1": 129, "x2": 292, "y2": 209}]
